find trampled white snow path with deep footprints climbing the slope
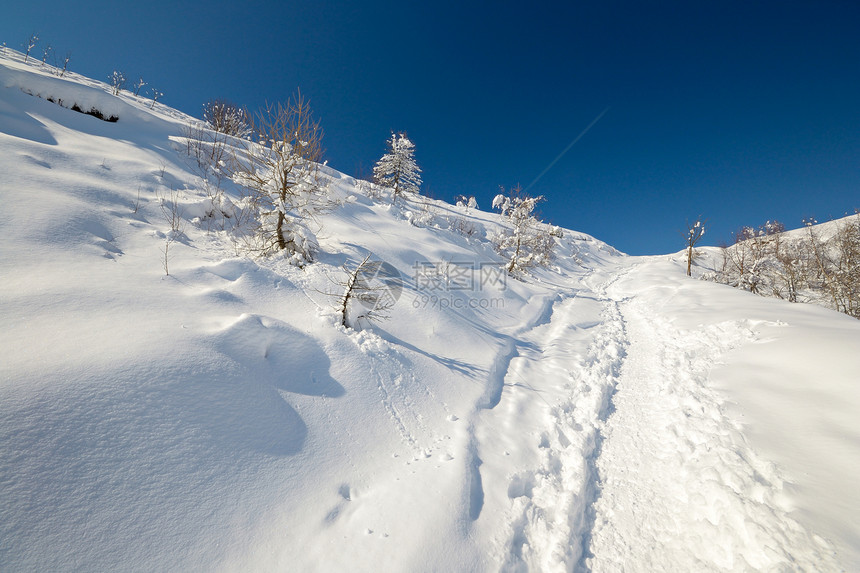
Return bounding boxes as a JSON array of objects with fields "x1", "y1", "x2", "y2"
[{"x1": 470, "y1": 262, "x2": 840, "y2": 571}]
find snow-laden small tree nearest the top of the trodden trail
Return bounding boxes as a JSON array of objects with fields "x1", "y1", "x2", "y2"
[{"x1": 493, "y1": 185, "x2": 561, "y2": 276}]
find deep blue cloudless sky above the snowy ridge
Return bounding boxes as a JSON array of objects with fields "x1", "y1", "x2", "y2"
[{"x1": 0, "y1": 0, "x2": 860, "y2": 254}]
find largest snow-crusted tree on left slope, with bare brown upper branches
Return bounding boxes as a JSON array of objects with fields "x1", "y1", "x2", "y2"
[{"x1": 230, "y1": 92, "x2": 329, "y2": 265}]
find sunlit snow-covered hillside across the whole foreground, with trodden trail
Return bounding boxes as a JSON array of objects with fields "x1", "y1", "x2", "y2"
[{"x1": 5, "y1": 50, "x2": 860, "y2": 571}]
